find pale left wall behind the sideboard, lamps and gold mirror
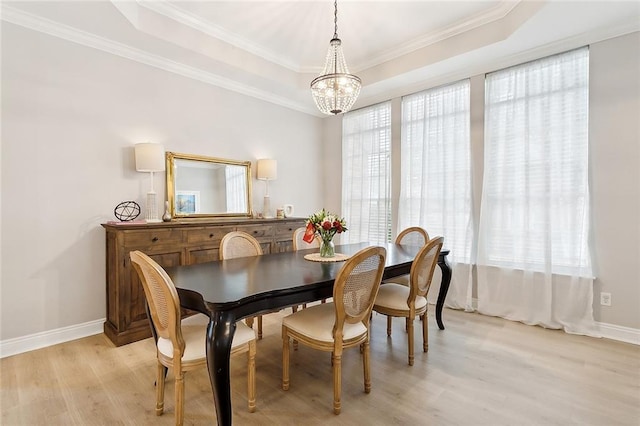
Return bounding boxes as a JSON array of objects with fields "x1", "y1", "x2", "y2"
[{"x1": 0, "y1": 22, "x2": 323, "y2": 341}]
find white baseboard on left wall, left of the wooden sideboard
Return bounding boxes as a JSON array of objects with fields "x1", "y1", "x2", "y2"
[{"x1": 0, "y1": 318, "x2": 105, "y2": 358}]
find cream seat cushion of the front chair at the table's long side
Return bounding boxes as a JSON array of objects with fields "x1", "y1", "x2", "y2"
[{"x1": 282, "y1": 303, "x2": 367, "y2": 342}]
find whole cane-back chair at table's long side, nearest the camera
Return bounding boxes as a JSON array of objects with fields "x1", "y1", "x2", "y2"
[{"x1": 282, "y1": 247, "x2": 386, "y2": 414}]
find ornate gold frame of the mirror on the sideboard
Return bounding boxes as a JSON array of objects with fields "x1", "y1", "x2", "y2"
[{"x1": 166, "y1": 151, "x2": 253, "y2": 219}]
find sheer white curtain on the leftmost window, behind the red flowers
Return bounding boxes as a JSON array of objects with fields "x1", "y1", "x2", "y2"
[{"x1": 340, "y1": 102, "x2": 391, "y2": 244}]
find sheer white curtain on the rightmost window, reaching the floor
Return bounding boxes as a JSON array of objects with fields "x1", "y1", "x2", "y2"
[{"x1": 478, "y1": 48, "x2": 596, "y2": 335}]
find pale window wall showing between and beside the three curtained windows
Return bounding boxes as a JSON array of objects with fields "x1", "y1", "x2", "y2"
[{"x1": 323, "y1": 32, "x2": 640, "y2": 333}]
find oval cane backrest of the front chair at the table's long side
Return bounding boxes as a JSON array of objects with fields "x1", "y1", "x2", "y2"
[{"x1": 333, "y1": 247, "x2": 387, "y2": 336}]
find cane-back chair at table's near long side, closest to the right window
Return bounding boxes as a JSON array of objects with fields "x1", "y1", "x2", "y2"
[{"x1": 373, "y1": 237, "x2": 444, "y2": 365}]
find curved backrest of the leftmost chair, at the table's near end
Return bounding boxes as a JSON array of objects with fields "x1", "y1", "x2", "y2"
[{"x1": 129, "y1": 250, "x2": 185, "y2": 359}]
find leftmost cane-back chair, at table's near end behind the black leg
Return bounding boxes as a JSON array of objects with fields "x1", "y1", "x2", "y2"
[{"x1": 129, "y1": 251, "x2": 256, "y2": 425}]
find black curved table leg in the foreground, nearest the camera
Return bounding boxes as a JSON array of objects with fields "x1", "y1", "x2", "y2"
[{"x1": 207, "y1": 313, "x2": 236, "y2": 425}]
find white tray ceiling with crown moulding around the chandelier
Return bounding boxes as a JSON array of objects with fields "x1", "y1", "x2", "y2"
[{"x1": 2, "y1": 0, "x2": 640, "y2": 115}]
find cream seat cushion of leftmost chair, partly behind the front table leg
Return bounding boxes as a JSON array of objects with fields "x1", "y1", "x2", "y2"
[{"x1": 158, "y1": 314, "x2": 256, "y2": 362}]
